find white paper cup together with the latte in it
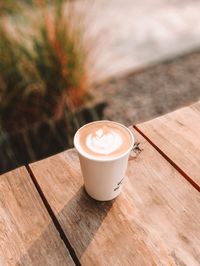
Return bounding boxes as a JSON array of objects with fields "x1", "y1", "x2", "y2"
[{"x1": 74, "y1": 120, "x2": 134, "y2": 201}]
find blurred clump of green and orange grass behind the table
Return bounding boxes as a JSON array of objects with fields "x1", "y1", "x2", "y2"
[{"x1": 0, "y1": 0, "x2": 88, "y2": 129}]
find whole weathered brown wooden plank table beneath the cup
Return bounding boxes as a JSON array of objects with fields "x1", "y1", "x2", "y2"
[{"x1": 0, "y1": 102, "x2": 200, "y2": 266}]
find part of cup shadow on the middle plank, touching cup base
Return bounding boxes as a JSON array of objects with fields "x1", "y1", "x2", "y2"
[{"x1": 57, "y1": 186, "x2": 114, "y2": 259}]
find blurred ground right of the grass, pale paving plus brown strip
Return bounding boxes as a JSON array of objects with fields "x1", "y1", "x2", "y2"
[{"x1": 79, "y1": 0, "x2": 200, "y2": 125}]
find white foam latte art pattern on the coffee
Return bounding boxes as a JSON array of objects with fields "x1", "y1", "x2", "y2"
[{"x1": 86, "y1": 128, "x2": 122, "y2": 154}]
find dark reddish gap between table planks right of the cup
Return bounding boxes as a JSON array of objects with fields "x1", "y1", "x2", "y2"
[{"x1": 133, "y1": 125, "x2": 200, "y2": 192}]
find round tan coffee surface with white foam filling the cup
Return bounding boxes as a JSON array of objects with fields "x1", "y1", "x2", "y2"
[{"x1": 75, "y1": 121, "x2": 133, "y2": 159}]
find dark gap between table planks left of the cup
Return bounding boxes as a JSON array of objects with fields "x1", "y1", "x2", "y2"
[{"x1": 25, "y1": 165, "x2": 81, "y2": 266}]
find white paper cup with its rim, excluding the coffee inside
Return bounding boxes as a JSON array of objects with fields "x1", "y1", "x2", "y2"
[{"x1": 74, "y1": 121, "x2": 134, "y2": 201}]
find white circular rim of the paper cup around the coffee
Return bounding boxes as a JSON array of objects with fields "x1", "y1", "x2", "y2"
[{"x1": 73, "y1": 120, "x2": 135, "y2": 162}]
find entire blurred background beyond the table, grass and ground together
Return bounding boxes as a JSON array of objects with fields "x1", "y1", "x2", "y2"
[{"x1": 0, "y1": 0, "x2": 200, "y2": 174}]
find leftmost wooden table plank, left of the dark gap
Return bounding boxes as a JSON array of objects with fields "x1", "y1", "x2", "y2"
[{"x1": 0, "y1": 167, "x2": 74, "y2": 266}]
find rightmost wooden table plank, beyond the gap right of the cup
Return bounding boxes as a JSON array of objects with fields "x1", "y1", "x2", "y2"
[{"x1": 137, "y1": 102, "x2": 200, "y2": 190}]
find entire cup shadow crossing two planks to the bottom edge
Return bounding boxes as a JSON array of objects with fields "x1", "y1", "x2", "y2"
[{"x1": 16, "y1": 186, "x2": 114, "y2": 266}]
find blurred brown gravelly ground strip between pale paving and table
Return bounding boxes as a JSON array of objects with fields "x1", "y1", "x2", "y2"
[{"x1": 91, "y1": 50, "x2": 200, "y2": 126}]
